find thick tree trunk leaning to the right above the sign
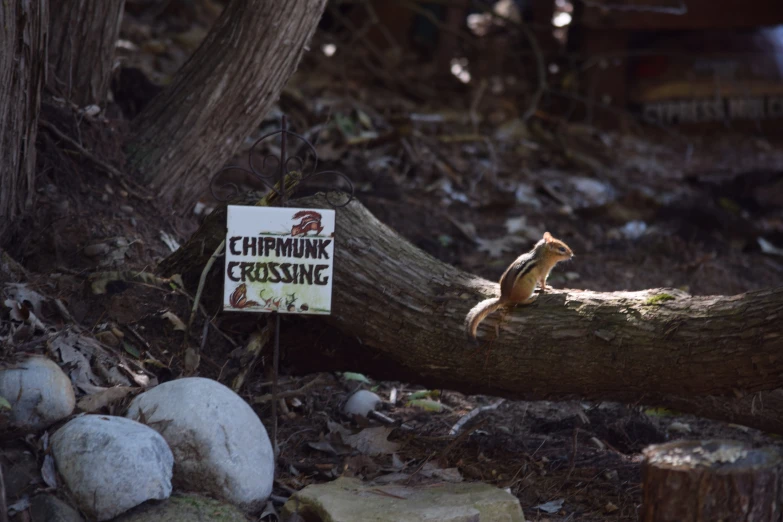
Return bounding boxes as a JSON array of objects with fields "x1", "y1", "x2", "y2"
[{"x1": 126, "y1": 0, "x2": 326, "y2": 208}]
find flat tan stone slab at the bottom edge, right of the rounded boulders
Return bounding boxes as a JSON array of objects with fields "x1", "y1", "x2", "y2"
[{"x1": 282, "y1": 477, "x2": 525, "y2": 522}]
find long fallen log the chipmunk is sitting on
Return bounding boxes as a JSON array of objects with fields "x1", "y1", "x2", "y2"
[{"x1": 161, "y1": 196, "x2": 783, "y2": 432}]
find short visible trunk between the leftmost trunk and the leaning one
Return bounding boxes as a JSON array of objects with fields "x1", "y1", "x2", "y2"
[{"x1": 48, "y1": 0, "x2": 125, "y2": 107}]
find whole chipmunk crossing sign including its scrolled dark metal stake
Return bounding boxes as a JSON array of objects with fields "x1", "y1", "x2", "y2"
[{"x1": 210, "y1": 116, "x2": 354, "y2": 457}]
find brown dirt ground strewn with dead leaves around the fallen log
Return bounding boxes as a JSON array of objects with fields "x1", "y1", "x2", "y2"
[{"x1": 8, "y1": 5, "x2": 783, "y2": 521}]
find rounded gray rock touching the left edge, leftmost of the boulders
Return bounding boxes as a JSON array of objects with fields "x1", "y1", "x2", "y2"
[{"x1": 0, "y1": 356, "x2": 76, "y2": 431}]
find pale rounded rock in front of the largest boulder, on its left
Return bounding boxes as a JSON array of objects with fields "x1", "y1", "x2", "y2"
[{"x1": 52, "y1": 415, "x2": 174, "y2": 521}]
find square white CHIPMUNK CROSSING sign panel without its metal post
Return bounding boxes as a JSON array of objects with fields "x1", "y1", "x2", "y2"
[{"x1": 223, "y1": 205, "x2": 334, "y2": 314}]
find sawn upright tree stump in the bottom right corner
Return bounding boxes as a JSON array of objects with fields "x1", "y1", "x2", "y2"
[{"x1": 642, "y1": 440, "x2": 783, "y2": 522}]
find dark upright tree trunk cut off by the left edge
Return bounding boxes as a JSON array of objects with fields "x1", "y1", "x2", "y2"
[{"x1": 0, "y1": 0, "x2": 49, "y2": 244}]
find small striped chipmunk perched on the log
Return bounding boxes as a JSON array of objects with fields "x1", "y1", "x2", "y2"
[{"x1": 465, "y1": 232, "x2": 574, "y2": 343}]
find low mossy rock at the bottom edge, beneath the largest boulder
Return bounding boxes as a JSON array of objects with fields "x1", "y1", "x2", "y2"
[{"x1": 112, "y1": 494, "x2": 248, "y2": 522}]
